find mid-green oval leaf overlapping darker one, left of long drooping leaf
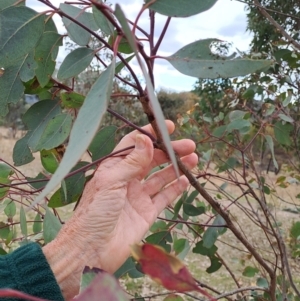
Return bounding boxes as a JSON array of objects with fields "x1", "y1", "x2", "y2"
[{"x1": 35, "y1": 114, "x2": 72, "y2": 150}]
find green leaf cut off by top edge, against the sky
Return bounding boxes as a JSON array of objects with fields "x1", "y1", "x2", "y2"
[{"x1": 145, "y1": 0, "x2": 217, "y2": 18}]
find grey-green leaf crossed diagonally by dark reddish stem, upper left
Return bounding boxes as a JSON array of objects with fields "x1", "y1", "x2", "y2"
[{"x1": 59, "y1": 3, "x2": 98, "y2": 46}]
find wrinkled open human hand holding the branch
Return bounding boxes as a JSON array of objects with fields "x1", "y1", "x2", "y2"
[{"x1": 44, "y1": 121, "x2": 198, "y2": 298}]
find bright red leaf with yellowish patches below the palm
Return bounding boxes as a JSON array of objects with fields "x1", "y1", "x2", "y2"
[{"x1": 131, "y1": 243, "x2": 216, "y2": 301}]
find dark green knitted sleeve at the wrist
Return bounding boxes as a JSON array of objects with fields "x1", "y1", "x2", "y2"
[{"x1": 0, "y1": 243, "x2": 64, "y2": 301}]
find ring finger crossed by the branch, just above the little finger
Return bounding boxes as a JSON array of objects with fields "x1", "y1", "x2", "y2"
[{"x1": 143, "y1": 153, "x2": 198, "y2": 196}]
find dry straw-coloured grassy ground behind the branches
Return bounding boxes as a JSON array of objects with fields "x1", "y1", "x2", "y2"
[{"x1": 0, "y1": 128, "x2": 300, "y2": 300}]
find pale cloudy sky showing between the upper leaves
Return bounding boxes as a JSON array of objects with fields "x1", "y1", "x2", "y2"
[{"x1": 27, "y1": 0, "x2": 251, "y2": 91}]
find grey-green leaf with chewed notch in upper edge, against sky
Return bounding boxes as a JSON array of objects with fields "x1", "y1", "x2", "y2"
[{"x1": 165, "y1": 39, "x2": 273, "y2": 79}]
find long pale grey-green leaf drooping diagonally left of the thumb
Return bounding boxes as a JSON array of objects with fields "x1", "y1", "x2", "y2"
[{"x1": 32, "y1": 60, "x2": 115, "y2": 206}]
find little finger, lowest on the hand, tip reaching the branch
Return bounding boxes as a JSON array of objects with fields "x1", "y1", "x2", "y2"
[{"x1": 152, "y1": 176, "x2": 189, "y2": 215}]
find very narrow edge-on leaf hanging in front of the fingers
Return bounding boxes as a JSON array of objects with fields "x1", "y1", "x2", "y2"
[{"x1": 115, "y1": 4, "x2": 179, "y2": 178}]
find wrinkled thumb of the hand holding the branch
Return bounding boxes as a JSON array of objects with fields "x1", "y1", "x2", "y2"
[{"x1": 113, "y1": 134, "x2": 154, "y2": 182}]
